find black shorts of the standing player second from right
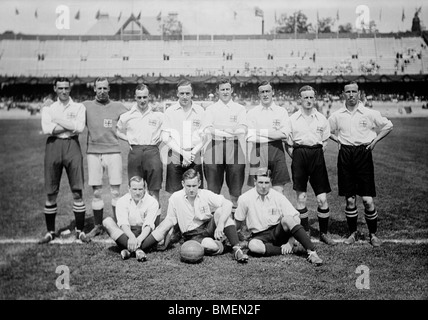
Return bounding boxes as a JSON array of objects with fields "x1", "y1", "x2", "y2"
[{"x1": 291, "y1": 145, "x2": 331, "y2": 195}]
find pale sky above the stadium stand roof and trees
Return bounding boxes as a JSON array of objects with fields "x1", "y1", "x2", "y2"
[{"x1": 0, "y1": 0, "x2": 428, "y2": 35}]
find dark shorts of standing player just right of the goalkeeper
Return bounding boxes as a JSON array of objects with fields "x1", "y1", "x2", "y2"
[{"x1": 128, "y1": 145, "x2": 163, "y2": 191}]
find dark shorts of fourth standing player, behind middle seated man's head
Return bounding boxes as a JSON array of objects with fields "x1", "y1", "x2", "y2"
[{"x1": 165, "y1": 150, "x2": 204, "y2": 193}]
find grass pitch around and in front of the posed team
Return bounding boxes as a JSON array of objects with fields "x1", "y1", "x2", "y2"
[{"x1": 0, "y1": 118, "x2": 428, "y2": 302}]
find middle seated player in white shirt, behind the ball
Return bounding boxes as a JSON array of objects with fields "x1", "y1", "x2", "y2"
[{"x1": 133, "y1": 169, "x2": 248, "y2": 263}]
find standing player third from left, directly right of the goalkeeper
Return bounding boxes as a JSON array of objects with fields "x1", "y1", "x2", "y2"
[{"x1": 117, "y1": 84, "x2": 163, "y2": 202}]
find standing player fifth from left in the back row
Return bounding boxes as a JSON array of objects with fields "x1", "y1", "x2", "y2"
[{"x1": 204, "y1": 78, "x2": 247, "y2": 212}]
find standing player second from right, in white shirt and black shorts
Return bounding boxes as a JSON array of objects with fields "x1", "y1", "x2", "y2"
[{"x1": 287, "y1": 86, "x2": 336, "y2": 245}]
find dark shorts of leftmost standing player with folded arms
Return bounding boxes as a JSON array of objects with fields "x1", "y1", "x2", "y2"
[{"x1": 44, "y1": 136, "x2": 84, "y2": 194}]
